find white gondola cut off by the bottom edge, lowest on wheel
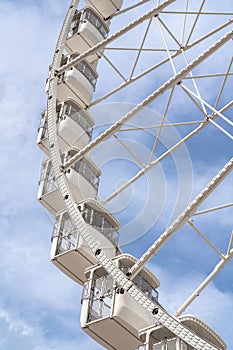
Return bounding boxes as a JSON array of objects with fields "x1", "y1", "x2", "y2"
[{"x1": 138, "y1": 315, "x2": 226, "y2": 350}]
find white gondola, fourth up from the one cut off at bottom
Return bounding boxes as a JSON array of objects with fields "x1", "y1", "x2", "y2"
[{"x1": 38, "y1": 151, "x2": 101, "y2": 216}]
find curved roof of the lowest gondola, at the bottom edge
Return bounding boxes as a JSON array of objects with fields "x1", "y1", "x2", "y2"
[{"x1": 139, "y1": 315, "x2": 227, "y2": 350}]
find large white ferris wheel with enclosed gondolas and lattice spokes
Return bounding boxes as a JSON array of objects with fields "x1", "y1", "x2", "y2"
[{"x1": 38, "y1": 0, "x2": 233, "y2": 350}]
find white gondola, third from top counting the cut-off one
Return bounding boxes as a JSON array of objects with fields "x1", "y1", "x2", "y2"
[{"x1": 57, "y1": 54, "x2": 98, "y2": 108}]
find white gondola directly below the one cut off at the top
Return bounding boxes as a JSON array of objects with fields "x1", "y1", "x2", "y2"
[{"x1": 65, "y1": 7, "x2": 109, "y2": 63}]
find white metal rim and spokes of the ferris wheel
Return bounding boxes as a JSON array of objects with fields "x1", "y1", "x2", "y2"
[{"x1": 44, "y1": 0, "x2": 233, "y2": 350}]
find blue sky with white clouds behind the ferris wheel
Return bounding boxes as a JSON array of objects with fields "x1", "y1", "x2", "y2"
[{"x1": 0, "y1": 0, "x2": 233, "y2": 350}]
